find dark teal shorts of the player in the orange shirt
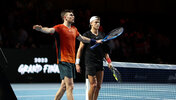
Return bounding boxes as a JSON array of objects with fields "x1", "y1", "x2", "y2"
[{"x1": 59, "y1": 62, "x2": 76, "y2": 80}]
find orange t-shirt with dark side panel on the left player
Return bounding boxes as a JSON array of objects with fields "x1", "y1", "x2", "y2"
[{"x1": 53, "y1": 24, "x2": 79, "y2": 63}]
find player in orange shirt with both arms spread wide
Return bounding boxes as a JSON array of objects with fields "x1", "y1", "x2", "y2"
[{"x1": 33, "y1": 10, "x2": 101, "y2": 100}]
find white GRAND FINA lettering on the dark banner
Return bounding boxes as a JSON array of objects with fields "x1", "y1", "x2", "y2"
[{"x1": 18, "y1": 64, "x2": 60, "y2": 75}]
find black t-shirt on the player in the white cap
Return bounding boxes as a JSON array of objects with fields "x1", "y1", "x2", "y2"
[{"x1": 83, "y1": 31, "x2": 109, "y2": 66}]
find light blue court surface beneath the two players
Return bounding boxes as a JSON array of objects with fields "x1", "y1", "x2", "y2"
[{"x1": 11, "y1": 83, "x2": 176, "y2": 100}]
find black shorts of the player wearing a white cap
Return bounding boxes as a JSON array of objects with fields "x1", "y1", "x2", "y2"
[{"x1": 86, "y1": 66, "x2": 104, "y2": 76}]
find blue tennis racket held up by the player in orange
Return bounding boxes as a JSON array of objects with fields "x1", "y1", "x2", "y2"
[{"x1": 90, "y1": 27, "x2": 124, "y2": 49}]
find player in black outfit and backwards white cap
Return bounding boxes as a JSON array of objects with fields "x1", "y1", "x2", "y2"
[{"x1": 75, "y1": 16, "x2": 112, "y2": 100}]
